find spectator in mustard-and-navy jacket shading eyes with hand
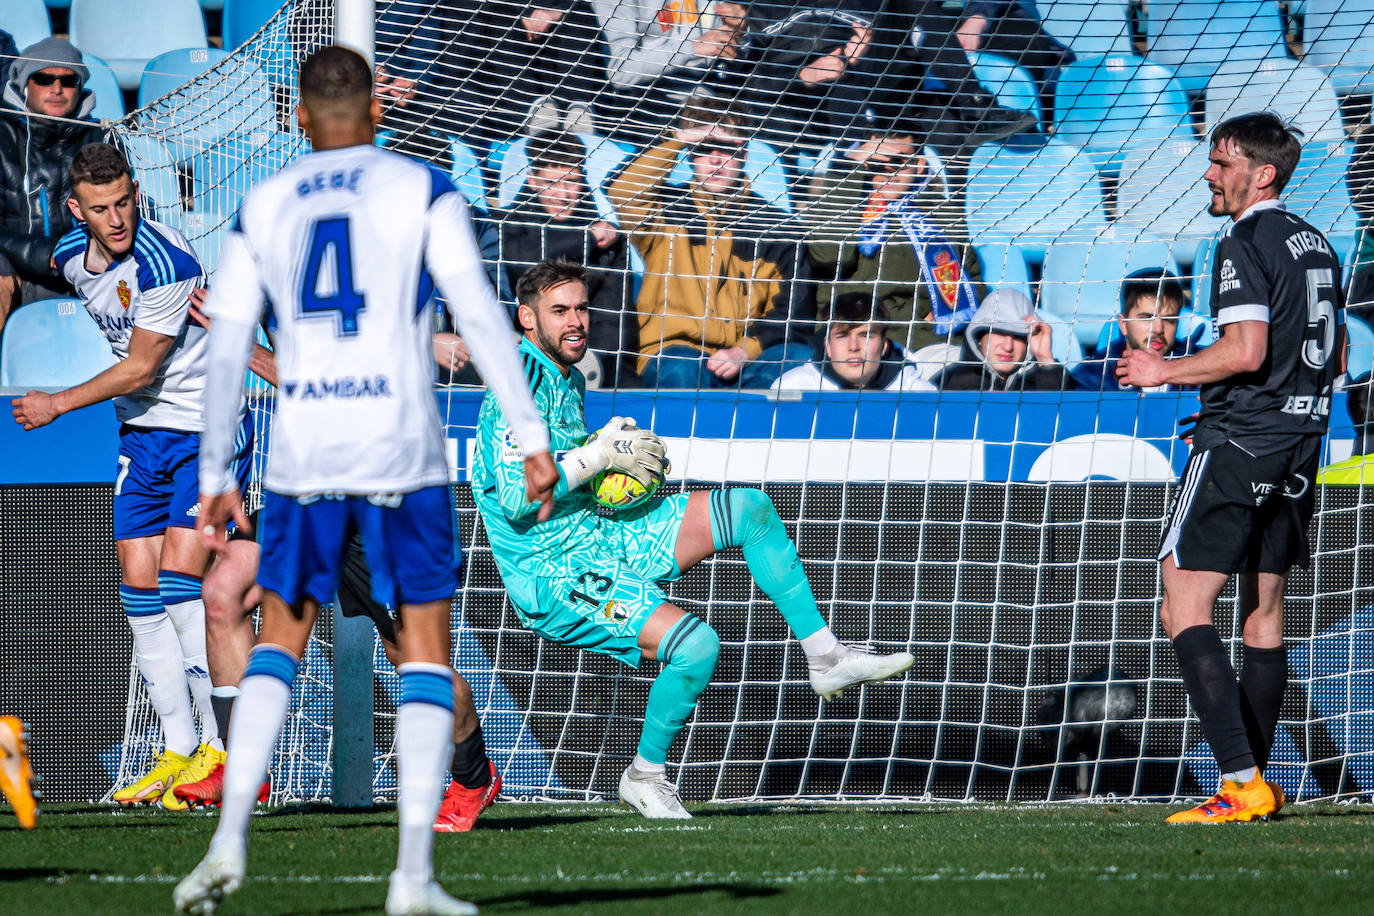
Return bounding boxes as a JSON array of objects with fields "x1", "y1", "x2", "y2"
[{"x1": 607, "y1": 98, "x2": 816, "y2": 389}]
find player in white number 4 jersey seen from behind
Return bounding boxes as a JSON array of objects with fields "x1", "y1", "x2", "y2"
[{"x1": 174, "y1": 47, "x2": 558, "y2": 913}]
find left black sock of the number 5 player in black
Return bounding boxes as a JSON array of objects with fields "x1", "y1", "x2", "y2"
[{"x1": 1173, "y1": 623, "x2": 1254, "y2": 773}]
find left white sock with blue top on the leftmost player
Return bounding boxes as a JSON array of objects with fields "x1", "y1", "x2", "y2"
[{"x1": 120, "y1": 585, "x2": 196, "y2": 757}]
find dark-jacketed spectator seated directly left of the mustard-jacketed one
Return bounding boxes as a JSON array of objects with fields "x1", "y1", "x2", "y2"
[{"x1": 493, "y1": 132, "x2": 639, "y2": 387}]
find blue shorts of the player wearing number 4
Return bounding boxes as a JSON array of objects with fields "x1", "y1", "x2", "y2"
[{"x1": 257, "y1": 486, "x2": 462, "y2": 608}]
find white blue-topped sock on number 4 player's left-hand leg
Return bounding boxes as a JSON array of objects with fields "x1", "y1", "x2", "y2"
[{"x1": 210, "y1": 645, "x2": 297, "y2": 846}]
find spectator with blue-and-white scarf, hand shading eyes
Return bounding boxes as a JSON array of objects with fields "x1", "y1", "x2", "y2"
[{"x1": 801, "y1": 126, "x2": 982, "y2": 373}]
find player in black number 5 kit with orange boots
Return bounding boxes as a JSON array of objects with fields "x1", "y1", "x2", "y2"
[{"x1": 1117, "y1": 113, "x2": 1345, "y2": 824}]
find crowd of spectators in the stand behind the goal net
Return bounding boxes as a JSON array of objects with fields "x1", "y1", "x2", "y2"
[{"x1": 0, "y1": 6, "x2": 1374, "y2": 391}]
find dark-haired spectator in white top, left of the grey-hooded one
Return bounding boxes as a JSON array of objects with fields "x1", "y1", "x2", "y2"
[{"x1": 772, "y1": 293, "x2": 936, "y2": 391}]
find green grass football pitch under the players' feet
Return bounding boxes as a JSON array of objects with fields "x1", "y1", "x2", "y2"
[{"x1": 0, "y1": 802, "x2": 1374, "y2": 916}]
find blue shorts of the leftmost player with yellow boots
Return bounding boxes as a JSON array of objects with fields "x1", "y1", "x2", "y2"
[{"x1": 114, "y1": 413, "x2": 253, "y2": 541}]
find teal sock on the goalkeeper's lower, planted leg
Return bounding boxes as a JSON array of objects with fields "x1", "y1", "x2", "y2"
[{"x1": 638, "y1": 614, "x2": 720, "y2": 765}]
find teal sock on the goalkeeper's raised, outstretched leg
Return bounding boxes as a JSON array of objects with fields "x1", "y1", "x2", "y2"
[{"x1": 710, "y1": 486, "x2": 826, "y2": 639}]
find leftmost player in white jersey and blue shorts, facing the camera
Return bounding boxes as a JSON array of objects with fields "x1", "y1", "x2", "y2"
[{"x1": 14, "y1": 143, "x2": 251, "y2": 809}]
